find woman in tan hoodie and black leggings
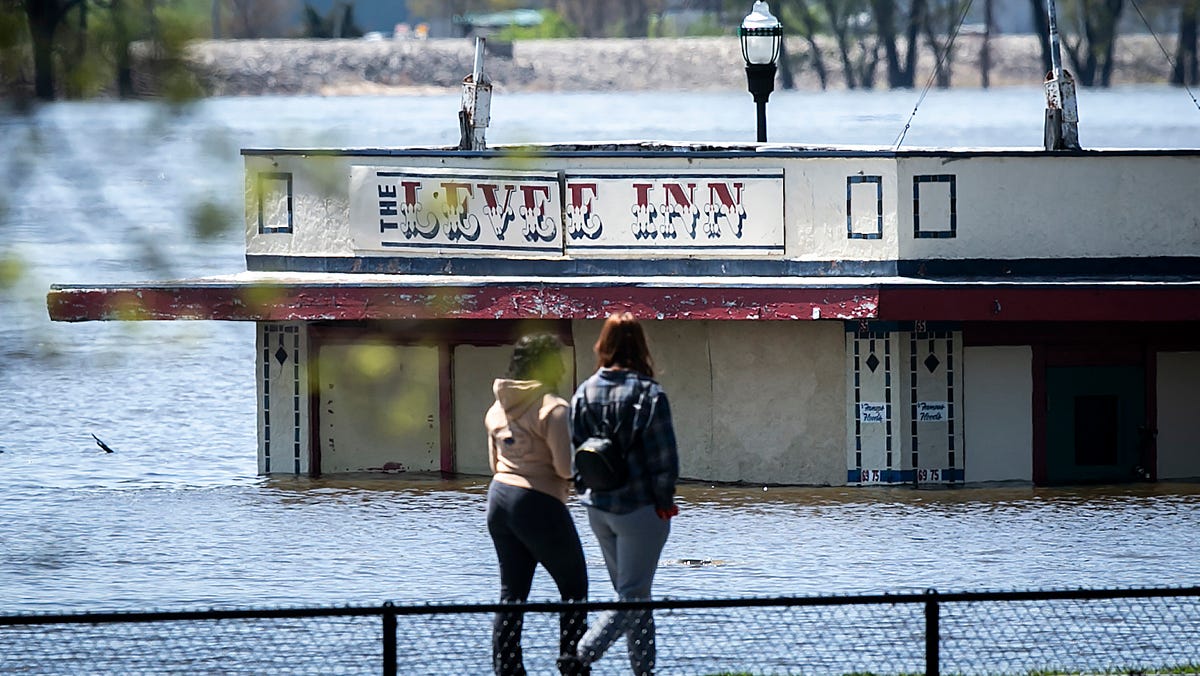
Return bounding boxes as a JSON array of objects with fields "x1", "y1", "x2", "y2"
[{"x1": 485, "y1": 335, "x2": 588, "y2": 676}]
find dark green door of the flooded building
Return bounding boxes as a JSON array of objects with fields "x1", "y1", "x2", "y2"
[{"x1": 1046, "y1": 366, "x2": 1146, "y2": 484}]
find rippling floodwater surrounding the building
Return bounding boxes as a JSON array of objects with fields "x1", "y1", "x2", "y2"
[{"x1": 0, "y1": 86, "x2": 1200, "y2": 612}]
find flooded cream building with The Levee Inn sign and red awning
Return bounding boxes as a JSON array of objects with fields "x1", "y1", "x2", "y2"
[{"x1": 48, "y1": 143, "x2": 1200, "y2": 485}]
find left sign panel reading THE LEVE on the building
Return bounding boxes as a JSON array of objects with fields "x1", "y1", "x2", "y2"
[{"x1": 350, "y1": 167, "x2": 563, "y2": 256}]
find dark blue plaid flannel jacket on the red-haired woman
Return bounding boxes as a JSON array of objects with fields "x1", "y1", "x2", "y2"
[{"x1": 571, "y1": 369, "x2": 679, "y2": 514}]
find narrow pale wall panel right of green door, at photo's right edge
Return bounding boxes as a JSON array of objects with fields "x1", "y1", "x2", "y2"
[{"x1": 1157, "y1": 352, "x2": 1200, "y2": 479}]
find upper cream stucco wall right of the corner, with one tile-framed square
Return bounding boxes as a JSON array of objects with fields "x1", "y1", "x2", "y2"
[{"x1": 898, "y1": 155, "x2": 1200, "y2": 259}]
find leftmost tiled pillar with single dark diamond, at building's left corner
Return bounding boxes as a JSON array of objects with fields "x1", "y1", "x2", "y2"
[{"x1": 254, "y1": 322, "x2": 310, "y2": 474}]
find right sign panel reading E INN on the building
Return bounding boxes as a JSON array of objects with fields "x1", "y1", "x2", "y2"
[{"x1": 563, "y1": 169, "x2": 784, "y2": 256}]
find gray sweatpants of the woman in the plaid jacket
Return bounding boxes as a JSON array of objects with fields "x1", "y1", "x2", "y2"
[{"x1": 578, "y1": 505, "x2": 671, "y2": 676}]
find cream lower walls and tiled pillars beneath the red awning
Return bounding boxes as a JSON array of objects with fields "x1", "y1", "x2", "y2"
[{"x1": 256, "y1": 319, "x2": 1200, "y2": 485}]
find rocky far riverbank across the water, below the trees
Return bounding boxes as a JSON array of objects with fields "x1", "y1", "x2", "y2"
[{"x1": 174, "y1": 35, "x2": 1171, "y2": 96}]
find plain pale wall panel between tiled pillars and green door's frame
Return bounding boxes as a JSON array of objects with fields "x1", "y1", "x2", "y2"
[{"x1": 962, "y1": 346, "x2": 1033, "y2": 483}]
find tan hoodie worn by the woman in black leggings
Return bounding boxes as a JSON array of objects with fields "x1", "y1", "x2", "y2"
[{"x1": 484, "y1": 378, "x2": 571, "y2": 503}]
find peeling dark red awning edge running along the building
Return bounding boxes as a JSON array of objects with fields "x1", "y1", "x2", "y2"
[{"x1": 47, "y1": 282, "x2": 1200, "y2": 322}]
